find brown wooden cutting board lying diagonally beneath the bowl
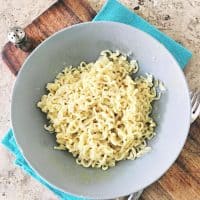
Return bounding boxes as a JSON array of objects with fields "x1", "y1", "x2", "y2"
[{"x1": 1, "y1": 0, "x2": 200, "y2": 200}]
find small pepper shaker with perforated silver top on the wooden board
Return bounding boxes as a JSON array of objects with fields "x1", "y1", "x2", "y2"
[{"x1": 8, "y1": 27, "x2": 32, "y2": 52}]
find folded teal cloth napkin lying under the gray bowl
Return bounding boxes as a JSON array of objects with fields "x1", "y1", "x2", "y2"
[{"x1": 2, "y1": 0, "x2": 192, "y2": 200}]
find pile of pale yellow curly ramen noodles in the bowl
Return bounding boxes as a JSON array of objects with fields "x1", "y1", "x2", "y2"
[{"x1": 37, "y1": 50, "x2": 159, "y2": 170}]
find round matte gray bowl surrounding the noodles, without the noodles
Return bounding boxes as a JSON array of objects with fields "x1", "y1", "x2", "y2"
[{"x1": 12, "y1": 22, "x2": 190, "y2": 199}]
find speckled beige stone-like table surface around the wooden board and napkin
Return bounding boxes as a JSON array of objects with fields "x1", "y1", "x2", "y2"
[{"x1": 0, "y1": 0, "x2": 200, "y2": 200}]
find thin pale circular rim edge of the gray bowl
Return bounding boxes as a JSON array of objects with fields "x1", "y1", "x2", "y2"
[{"x1": 11, "y1": 21, "x2": 191, "y2": 200}]
